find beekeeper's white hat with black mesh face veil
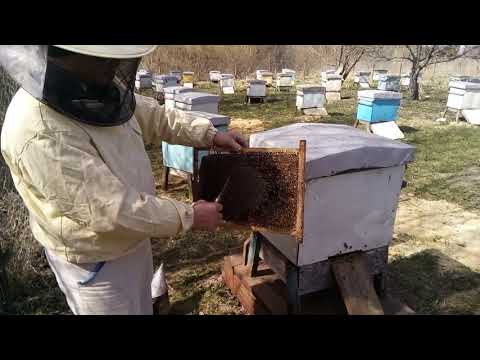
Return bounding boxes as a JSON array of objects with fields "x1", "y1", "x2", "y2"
[{"x1": 0, "y1": 45, "x2": 155, "y2": 126}]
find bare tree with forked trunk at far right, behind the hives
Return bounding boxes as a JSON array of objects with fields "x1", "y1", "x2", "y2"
[{"x1": 373, "y1": 45, "x2": 480, "y2": 100}]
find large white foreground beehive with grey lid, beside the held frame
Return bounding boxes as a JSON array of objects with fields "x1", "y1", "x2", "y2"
[{"x1": 250, "y1": 123, "x2": 414, "y2": 266}]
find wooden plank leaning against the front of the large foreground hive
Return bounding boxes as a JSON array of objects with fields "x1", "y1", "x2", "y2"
[{"x1": 330, "y1": 253, "x2": 384, "y2": 315}]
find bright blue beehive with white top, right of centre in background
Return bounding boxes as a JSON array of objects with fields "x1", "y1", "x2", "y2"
[{"x1": 357, "y1": 90, "x2": 402, "y2": 123}]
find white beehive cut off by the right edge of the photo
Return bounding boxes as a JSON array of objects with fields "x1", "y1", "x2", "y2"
[{"x1": 447, "y1": 81, "x2": 480, "y2": 110}]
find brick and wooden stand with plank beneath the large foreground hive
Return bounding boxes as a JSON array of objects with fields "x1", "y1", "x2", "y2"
[{"x1": 222, "y1": 231, "x2": 413, "y2": 315}]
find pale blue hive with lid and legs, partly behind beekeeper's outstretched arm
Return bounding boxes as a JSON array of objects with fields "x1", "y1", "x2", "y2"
[{"x1": 162, "y1": 111, "x2": 230, "y2": 200}]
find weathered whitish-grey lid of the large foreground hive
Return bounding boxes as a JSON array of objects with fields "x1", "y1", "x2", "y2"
[{"x1": 250, "y1": 123, "x2": 415, "y2": 180}]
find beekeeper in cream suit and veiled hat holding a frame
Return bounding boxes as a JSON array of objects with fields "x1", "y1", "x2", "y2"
[{"x1": 0, "y1": 45, "x2": 246, "y2": 314}]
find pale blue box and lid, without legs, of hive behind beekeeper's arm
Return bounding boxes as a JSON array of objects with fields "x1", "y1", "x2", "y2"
[{"x1": 162, "y1": 111, "x2": 230, "y2": 174}]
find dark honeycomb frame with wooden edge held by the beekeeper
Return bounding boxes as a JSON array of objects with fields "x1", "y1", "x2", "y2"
[{"x1": 199, "y1": 143, "x2": 304, "y2": 239}]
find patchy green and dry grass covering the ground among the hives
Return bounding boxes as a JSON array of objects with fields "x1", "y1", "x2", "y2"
[{"x1": 0, "y1": 77, "x2": 480, "y2": 314}]
